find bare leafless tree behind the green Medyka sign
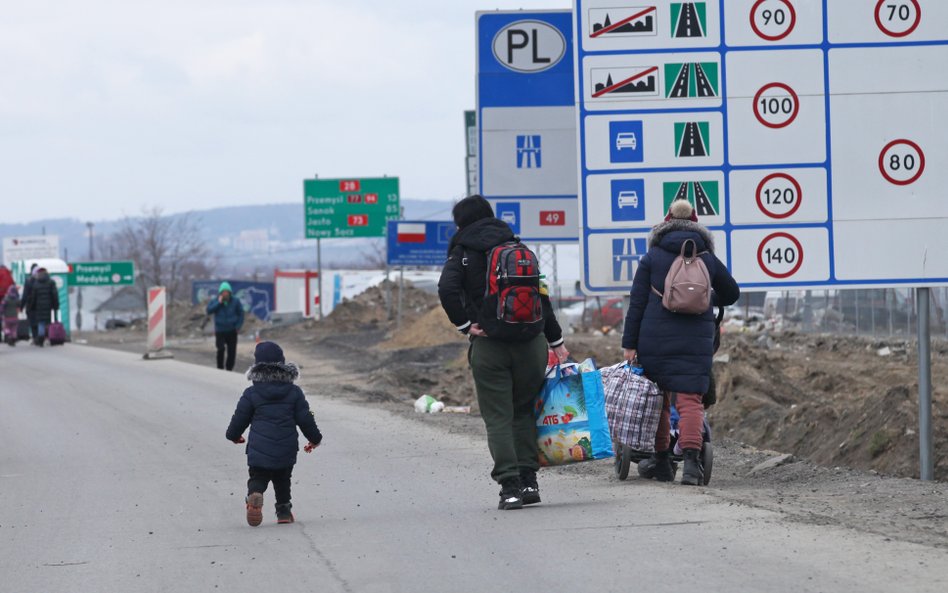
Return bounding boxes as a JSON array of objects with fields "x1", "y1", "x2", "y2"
[{"x1": 111, "y1": 207, "x2": 213, "y2": 302}]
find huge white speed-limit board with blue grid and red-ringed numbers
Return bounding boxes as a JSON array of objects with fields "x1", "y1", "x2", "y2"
[{"x1": 574, "y1": 0, "x2": 948, "y2": 294}]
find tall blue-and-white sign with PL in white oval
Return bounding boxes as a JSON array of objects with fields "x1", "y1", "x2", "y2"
[{"x1": 477, "y1": 10, "x2": 579, "y2": 243}]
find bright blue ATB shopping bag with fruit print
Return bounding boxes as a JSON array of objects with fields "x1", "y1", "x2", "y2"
[{"x1": 536, "y1": 364, "x2": 613, "y2": 466}]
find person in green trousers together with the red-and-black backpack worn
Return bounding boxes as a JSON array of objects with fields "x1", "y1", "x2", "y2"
[{"x1": 438, "y1": 195, "x2": 569, "y2": 510}]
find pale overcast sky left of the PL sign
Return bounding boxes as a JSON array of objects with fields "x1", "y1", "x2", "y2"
[{"x1": 0, "y1": 0, "x2": 570, "y2": 222}]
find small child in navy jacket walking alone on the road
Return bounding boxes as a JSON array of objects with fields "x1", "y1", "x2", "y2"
[{"x1": 227, "y1": 342, "x2": 323, "y2": 527}]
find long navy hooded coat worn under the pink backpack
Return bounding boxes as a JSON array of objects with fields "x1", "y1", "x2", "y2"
[{"x1": 622, "y1": 219, "x2": 741, "y2": 395}]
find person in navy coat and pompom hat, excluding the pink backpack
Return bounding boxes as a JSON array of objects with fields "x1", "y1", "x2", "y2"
[{"x1": 622, "y1": 200, "x2": 741, "y2": 485}]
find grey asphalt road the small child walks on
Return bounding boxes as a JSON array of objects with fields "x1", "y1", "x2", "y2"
[{"x1": 0, "y1": 345, "x2": 948, "y2": 593}]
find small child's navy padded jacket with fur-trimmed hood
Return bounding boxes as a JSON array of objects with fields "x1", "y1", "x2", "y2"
[{"x1": 227, "y1": 363, "x2": 323, "y2": 469}]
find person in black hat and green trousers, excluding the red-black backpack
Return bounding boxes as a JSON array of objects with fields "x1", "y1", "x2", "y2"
[{"x1": 438, "y1": 195, "x2": 569, "y2": 510}]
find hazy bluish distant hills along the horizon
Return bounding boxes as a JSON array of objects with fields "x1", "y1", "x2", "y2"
[{"x1": 0, "y1": 199, "x2": 453, "y2": 275}]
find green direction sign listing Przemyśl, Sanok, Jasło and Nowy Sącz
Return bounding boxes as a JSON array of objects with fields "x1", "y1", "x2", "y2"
[{"x1": 303, "y1": 177, "x2": 399, "y2": 239}]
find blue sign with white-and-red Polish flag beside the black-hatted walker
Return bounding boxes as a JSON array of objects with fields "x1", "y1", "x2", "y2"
[{"x1": 386, "y1": 220, "x2": 457, "y2": 266}]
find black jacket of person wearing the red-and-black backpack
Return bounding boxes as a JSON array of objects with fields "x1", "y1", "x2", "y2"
[{"x1": 438, "y1": 218, "x2": 563, "y2": 348}]
